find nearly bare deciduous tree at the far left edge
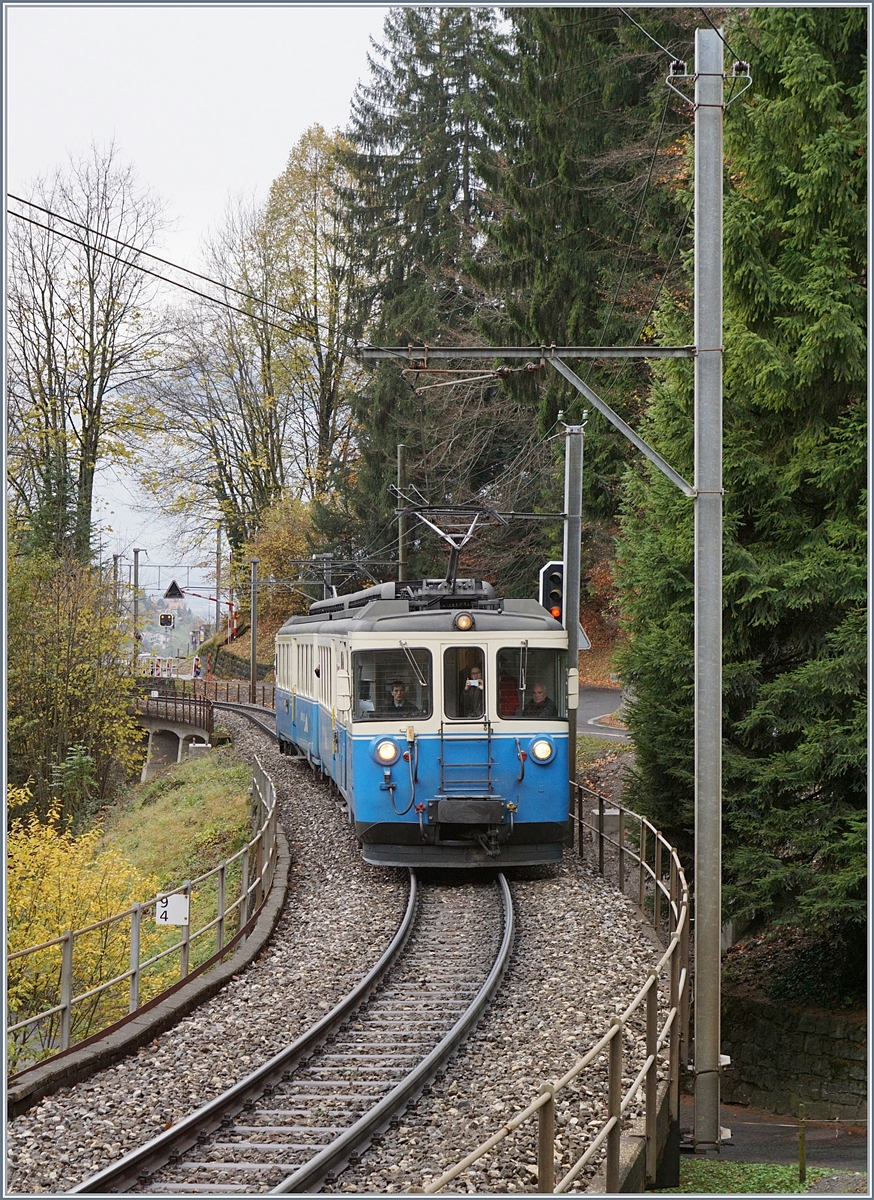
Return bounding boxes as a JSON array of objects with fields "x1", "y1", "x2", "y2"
[{"x1": 7, "y1": 145, "x2": 164, "y2": 560}]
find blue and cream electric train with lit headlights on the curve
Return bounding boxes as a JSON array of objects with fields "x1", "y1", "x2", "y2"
[{"x1": 276, "y1": 580, "x2": 577, "y2": 868}]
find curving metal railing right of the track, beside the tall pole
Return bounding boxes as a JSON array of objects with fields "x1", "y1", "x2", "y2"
[{"x1": 423, "y1": 784, "x2": 690, "y2": 1194}]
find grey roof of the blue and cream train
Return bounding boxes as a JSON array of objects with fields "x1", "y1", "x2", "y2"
[{"x1": 280, "y1": 580, "x2": 564, "y2": 634}]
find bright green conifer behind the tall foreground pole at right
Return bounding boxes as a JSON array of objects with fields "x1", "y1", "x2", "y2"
[{"x1": 623, "y1": 7, "x2": 867, "y2": 988}]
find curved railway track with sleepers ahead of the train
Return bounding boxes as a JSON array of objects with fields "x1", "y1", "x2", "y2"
[{"x1": 73, "y1": 871, "x2": 514, "y2": 1195}]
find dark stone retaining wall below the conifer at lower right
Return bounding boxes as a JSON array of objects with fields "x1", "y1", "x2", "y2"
[{"x1": 722, "y1": 990, "x2": 868, "y2": 1121}]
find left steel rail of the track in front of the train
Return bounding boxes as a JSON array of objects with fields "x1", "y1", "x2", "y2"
[{"x1": 66, "y1": 871, "x2": 418, "y2": 1195}]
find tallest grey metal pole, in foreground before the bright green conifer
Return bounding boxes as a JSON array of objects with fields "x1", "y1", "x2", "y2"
[{"x1": 695, "y1": 29, "x2": 724, "y2": 1150}]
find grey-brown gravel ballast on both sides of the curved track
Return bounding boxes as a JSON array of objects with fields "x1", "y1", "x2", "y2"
[{"x1": 6, "y1": 713, "x2": 658, "y2": 1195}]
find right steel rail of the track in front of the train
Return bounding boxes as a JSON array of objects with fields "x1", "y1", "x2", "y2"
[{"x1": 268, "y1": 875, "x2": 515, "y2": 1195}]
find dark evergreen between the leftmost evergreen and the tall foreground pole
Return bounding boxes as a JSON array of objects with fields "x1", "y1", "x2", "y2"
[{"x1": 473, "y1": 6, "x2": 690, "y2": 518}]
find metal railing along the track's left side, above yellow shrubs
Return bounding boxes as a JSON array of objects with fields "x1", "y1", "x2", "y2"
[{"x1": 6, "y1": 758, "x2": 277, "y2": 1070}]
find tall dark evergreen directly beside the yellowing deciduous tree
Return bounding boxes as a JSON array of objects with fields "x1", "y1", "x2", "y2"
[{"x1": 318, "y1": 7, "x2": 520, "y2": 574}]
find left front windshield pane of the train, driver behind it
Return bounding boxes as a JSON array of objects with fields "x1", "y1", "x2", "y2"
[{"x1": 352, "y1": 644, "x2": 432, "y2": 721}]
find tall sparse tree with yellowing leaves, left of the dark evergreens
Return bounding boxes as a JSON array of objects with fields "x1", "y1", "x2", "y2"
[{"x1": 144, "y1": 126, "x2": 355, "y2": 550}]
